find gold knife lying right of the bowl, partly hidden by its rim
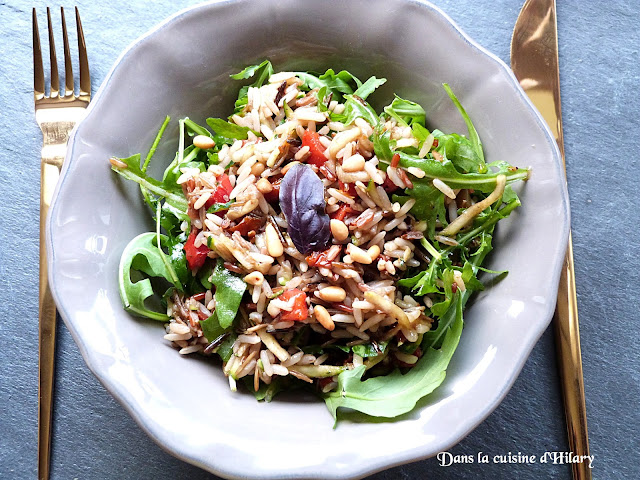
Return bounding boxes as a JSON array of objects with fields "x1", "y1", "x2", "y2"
[{"x1": 511, "y1": 0, "x2": 591, "y2": 480}]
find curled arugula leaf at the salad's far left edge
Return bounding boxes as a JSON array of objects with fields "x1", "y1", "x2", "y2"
[{"x1": 118, "y1": 232, "x2": 182, "y2": 322}]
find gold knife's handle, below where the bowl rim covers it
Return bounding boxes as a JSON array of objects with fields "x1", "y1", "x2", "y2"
[{"x1": 553, "y1": 232, "x2": 591, "y2": 480}]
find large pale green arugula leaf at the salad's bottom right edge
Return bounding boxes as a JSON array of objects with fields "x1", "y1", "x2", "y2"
[{"x1": 324, "y1": 295, "x2": 463, "y2": 421}]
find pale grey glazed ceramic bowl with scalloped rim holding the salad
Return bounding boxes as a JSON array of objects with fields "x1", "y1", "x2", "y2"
[{"x1": 48, "y1": 0, "x2": 569, "y2": 479}]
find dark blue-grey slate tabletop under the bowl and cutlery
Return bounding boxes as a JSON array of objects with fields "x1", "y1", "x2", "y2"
[{"x1": 0, "y1": 0, "x2": 640, "y2": 480}]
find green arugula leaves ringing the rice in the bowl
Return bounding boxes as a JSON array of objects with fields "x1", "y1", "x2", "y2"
[{"x1": 111, "y1": 60, "x2": 529, "y2": 422}]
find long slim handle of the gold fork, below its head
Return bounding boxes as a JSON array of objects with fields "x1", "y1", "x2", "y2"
[{"x1": 38, "y1": 160, "x2": 60, "y2": 480}]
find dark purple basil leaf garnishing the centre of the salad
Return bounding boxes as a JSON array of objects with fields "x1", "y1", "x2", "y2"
[{"x1": 280, "y1": 164, "x2": 331, "y2": 255}]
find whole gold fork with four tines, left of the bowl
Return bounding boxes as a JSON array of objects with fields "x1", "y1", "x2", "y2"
[{"x1": 33, "y1": 7, "x2": 91, "y2": 480}]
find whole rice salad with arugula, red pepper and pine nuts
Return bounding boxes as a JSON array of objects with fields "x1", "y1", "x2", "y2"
[{"x1": 110, "y1": 61, "x2": 529, "y2": 424}]
